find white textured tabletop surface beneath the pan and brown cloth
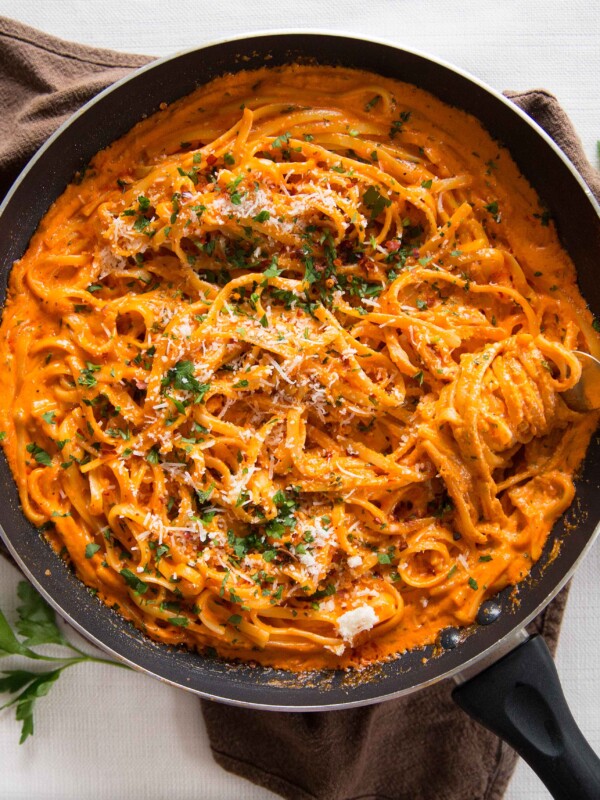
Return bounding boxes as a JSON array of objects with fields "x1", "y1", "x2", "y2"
[{"x1": 0, "y1": 0, "x2": 600, "y2": 800}]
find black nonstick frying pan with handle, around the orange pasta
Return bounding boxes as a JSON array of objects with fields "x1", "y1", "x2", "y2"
[{"x1": 0, "y1": 32, "x2": 600, "y2": 800}]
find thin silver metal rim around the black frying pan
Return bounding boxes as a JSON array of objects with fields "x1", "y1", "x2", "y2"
[{"x1": 0, "y1": 28, "x2": 600, "y2": 711}]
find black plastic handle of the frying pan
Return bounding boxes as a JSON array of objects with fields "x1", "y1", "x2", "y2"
[{"x1": 452, "y1": 636, "x2": 600, "y2": 800}]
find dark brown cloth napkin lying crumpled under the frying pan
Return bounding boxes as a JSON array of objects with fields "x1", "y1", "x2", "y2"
[{"x1": 0, "y1": 18, "x2": 600, "y2": 800}]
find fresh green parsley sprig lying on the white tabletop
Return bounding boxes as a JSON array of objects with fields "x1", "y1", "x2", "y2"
[{"x1": 0, "y1": 581, "x2": 129, "y2": 744}]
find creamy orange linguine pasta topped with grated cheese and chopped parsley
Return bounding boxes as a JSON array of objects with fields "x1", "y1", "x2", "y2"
[{"x1": 0, "y1": 65, "x2": 598, "y2": 670}]
